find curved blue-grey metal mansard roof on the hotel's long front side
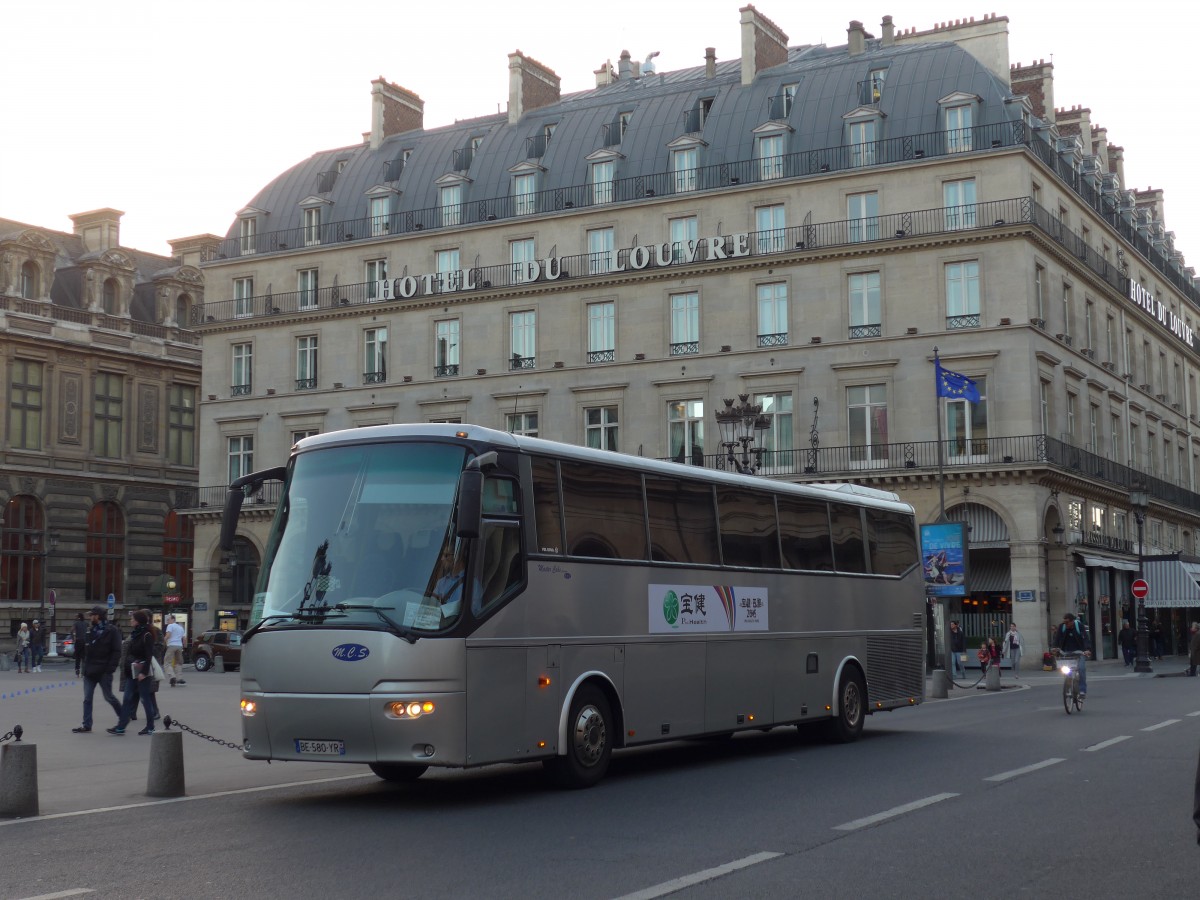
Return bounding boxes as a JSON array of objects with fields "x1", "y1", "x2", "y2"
[{"x1": 228, "y1": 41, "x2": 1020, "y2": 238}]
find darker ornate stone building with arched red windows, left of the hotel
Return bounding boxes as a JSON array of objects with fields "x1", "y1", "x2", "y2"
[{"x1": 0, "y1": 209, "x2": 204, "y2": 635}]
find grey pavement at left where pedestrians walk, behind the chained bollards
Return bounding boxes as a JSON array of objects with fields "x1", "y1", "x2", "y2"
[{"x1": 0, "y1": 658, "x2": 373, "y2": 827}]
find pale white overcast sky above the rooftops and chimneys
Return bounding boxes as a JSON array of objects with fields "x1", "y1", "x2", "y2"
[{"x1": 0, "y1": 0, "x2": 1200, "y2": 266}]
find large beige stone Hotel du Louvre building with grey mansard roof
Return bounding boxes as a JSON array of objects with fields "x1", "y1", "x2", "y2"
[{"x1": 193, "y1": 6, "x2": 1200, "y2": 667}]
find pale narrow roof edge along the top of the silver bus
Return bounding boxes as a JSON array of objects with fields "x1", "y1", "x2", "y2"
[{"x1": 293, "y1": 422, "x2": 912, "y2": 511}]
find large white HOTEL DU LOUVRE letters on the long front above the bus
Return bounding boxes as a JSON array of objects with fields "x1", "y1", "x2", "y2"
[{"x1": 376, "y1": 229, "x2": 758, "y2": 300}]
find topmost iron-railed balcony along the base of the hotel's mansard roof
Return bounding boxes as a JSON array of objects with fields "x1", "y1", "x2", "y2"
[{"x1": 204, "y1": 120, "x2": 1200, "y2": 305}]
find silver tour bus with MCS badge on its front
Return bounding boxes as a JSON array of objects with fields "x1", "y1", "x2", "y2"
[{"x1": 222, "y1": 425, "x2": 925, "y2": 787}]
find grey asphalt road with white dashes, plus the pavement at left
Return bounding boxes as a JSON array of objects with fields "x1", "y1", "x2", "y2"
[{"x1": 0, "y1": 661, "x2": 1200, "y2": 900}]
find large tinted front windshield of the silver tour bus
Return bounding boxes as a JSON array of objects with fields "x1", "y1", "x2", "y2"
[{"x1": 252, "y1": 443, "x2": 467, "y2": 632}]
